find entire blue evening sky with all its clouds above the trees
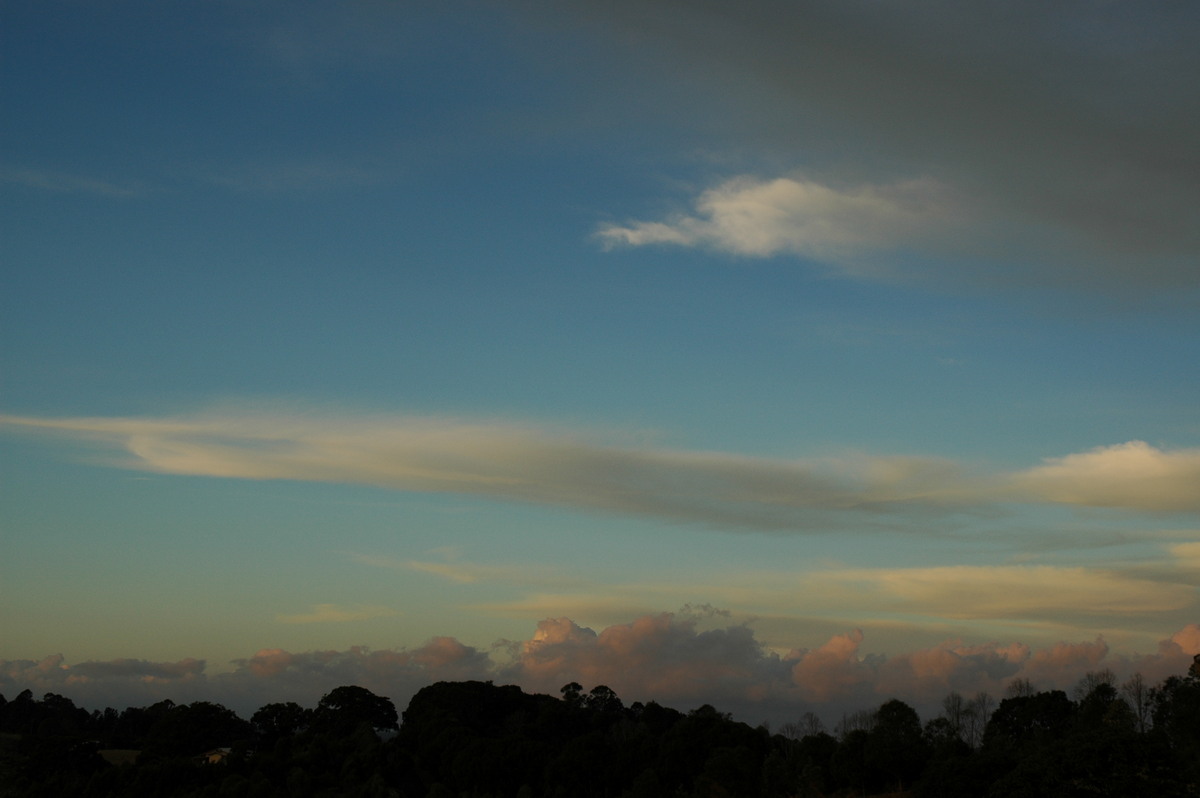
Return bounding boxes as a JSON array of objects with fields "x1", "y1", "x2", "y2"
[{"x1": 0, "y1": 0, "x2": 1200, "y2": 722}]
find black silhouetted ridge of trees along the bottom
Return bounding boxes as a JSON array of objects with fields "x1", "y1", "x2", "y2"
[{"x1": 0, "y1": 671, "x2": 1200, "y2": 798}]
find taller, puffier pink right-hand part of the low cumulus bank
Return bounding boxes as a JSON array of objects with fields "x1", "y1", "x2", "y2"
[{"x1": 500, "y1": 613, "x2": 1190, "y2": 720}]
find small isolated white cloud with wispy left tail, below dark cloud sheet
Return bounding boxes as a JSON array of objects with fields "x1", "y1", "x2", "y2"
[{"x1": 598, "y1": 176, "x2": 959, "y2": 271}]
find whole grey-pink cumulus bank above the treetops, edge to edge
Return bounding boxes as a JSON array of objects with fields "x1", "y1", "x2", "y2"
[{"x1": 0, "y1": 612, "x2": 1200, "y2": 722}]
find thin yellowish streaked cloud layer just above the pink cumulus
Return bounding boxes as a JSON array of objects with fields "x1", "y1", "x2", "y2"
[{"x1": 472, "y1": 556, "x2": 1200, "y2": 647}]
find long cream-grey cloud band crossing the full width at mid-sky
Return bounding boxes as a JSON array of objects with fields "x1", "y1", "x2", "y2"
[{"x1": 0, "y1": 413, "x2": 1200, "y2": 529}]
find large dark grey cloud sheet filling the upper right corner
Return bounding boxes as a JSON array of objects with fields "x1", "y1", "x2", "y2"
[{"x1": 532, "y1": 0, "x2": 1200, "y2": 297}]
